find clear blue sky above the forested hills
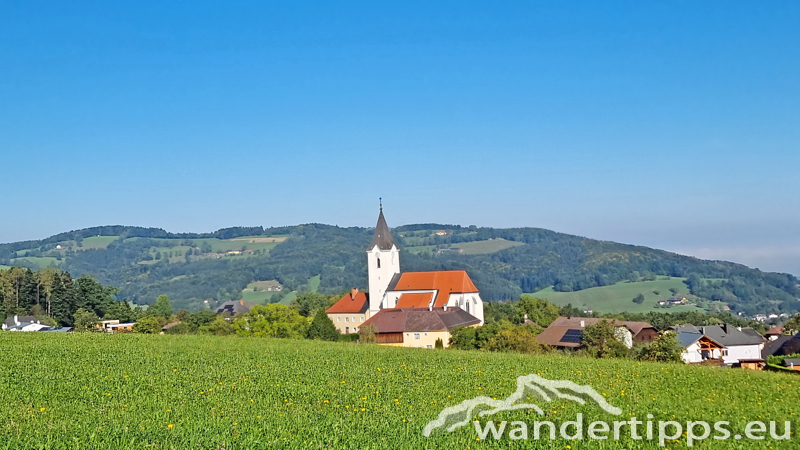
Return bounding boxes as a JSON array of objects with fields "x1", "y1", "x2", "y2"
[{"x1": 0, "y1": 0, "x2": 800, "y2": 275}]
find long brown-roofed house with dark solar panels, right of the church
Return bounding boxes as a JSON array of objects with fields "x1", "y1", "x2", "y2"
[{"x1": 536, "y1": 317, "x2": 658, "y2": 348}]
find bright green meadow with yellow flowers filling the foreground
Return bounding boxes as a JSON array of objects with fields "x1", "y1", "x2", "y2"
[{"x1": 0, "y1": 333, "x2": 800, "y2": 450}]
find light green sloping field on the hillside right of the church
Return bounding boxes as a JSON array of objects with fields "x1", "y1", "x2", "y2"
[{"x1": 530, "y1": 278, "x2": 699, "y2": 313}]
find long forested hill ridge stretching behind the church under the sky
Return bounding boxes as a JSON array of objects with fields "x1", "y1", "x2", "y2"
[{"x1": 0, "y1": 224, "x2": 800, "y2": 314}]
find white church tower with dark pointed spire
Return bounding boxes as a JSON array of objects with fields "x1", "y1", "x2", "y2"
[{"x1": 367, "y1": 203, "x2": 400, "y2": 315}]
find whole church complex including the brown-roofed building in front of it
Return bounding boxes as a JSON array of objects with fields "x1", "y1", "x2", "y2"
[{"x1": 327, "y1": 206, "x2": 483, "y2": 348}]
